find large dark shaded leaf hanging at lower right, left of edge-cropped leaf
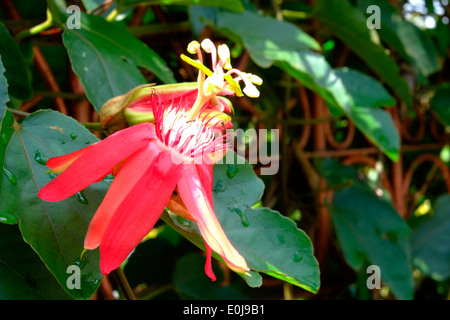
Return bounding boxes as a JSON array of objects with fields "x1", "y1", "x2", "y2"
[{"x1": 325, "y1": 160, "x2": 414, "y2": 299}]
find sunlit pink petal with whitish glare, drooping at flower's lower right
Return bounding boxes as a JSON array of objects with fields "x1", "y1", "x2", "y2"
[{"x1": 177, "y1": 164, "x2": 249, "y2": 273}]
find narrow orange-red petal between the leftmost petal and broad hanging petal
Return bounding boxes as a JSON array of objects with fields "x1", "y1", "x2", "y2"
[{"x1": 84, "y1": 143, "x2": 161, "y2": 250}]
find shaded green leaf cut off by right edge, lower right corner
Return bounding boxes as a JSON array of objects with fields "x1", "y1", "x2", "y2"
[{"x1": 411, "y1": 194, "x2": 450, "y2": 281}]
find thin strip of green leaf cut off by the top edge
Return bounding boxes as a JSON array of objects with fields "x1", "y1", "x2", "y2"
[{"x1": 117, "y1": 0, "x2": 244, "y2": 12}]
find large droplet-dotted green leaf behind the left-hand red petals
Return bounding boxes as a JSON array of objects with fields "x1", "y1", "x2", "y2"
[{"x1": 0, "y1": 110, "x2": 109, "y2": 299}]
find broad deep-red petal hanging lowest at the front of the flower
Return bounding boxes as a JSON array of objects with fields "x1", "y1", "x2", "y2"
[{"x1": 100, "y1": 150, "x2": 183, "y2": 274}]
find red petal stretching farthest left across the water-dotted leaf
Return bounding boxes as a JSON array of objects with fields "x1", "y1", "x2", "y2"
[{"x1": 38, "y1": 123, "x2": 156, "y2": 201}]
